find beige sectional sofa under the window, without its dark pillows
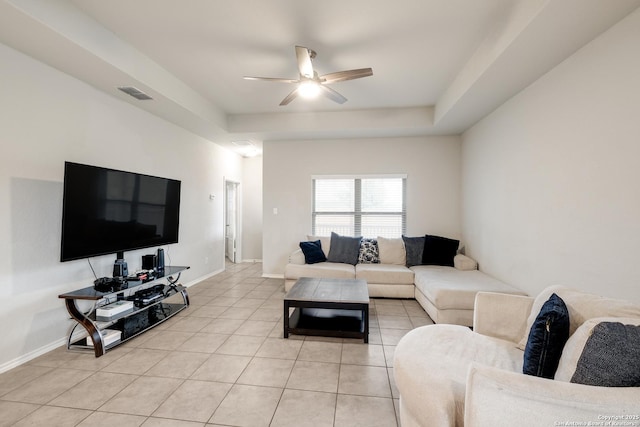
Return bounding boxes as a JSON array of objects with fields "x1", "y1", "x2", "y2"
[{"x1": 284, "y1": 236, "x2": 525, "y2": 326}]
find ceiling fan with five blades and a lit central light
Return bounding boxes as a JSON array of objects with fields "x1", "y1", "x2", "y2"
[{"x1": 244, "y1": 46, "x2": 373, "y2": 106}]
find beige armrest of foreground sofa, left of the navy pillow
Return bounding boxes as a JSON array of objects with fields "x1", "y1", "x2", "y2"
[{"x1": 473, "y1": 292, "x2": 534, "y2": 343}]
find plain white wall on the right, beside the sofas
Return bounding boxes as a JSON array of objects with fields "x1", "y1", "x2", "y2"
[{"x1": 462, "y1": 5, "x2": 640, "y2": 300}]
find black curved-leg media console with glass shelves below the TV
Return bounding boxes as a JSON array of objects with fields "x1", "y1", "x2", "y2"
[{"x1": 58, "y1": 266, "x2": 189, "y2": 357}]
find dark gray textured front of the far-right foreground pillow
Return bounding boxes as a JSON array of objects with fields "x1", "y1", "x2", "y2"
[{"x1": 571, "y1": 322, "x2": 640, "y2": 387}]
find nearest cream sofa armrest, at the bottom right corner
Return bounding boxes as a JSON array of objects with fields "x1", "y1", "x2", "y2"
[{"x1": 464, "y1": 364, "x2": 640, "y2": 427}]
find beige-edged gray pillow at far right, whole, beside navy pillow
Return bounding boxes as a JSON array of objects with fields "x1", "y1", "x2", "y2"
[{"x1": 555, "y1": 317, "x2": 640, "y2": 387}]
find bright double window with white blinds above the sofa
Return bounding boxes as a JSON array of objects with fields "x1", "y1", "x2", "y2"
[{"x1": 312, "y1": 175, "x2": 407, "y2": 237}]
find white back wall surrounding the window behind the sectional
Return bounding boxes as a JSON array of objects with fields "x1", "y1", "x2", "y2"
[{"x1": 262, "y1": 137, "x2": 461, "y2": 275}]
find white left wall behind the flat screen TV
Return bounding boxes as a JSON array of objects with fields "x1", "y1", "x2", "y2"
[{"x1": 0, "y1": 44, "x2": 242, "y2": 372}]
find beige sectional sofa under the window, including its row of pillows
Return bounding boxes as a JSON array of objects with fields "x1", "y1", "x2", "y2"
[{"x1": 284, "y1": 233, "x2": 525, "y2": 326}]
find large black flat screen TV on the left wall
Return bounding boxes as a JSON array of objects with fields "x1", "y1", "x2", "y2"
[{"x1": 60, "y1": 162, "x2": 181, "y2": 261}]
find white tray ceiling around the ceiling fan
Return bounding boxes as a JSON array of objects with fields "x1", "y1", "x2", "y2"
[{"x1": 0, "y1": 0, "x2": 640, "y2": 154}]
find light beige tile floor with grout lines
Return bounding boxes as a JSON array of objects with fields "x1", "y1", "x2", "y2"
[{"x1": 0, "y1": 263, "x2": 433, "y2": 427}]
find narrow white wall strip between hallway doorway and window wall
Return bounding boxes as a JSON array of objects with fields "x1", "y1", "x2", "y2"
[{"x1": 240, "y1": 157, "x2": 262, "y2": 261}]
